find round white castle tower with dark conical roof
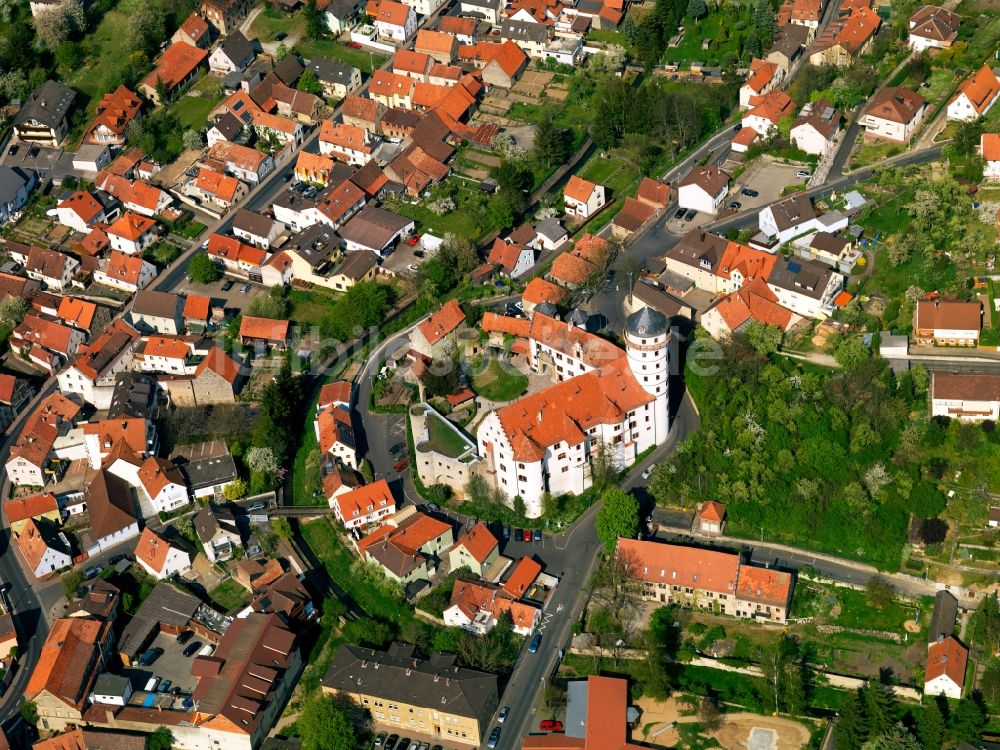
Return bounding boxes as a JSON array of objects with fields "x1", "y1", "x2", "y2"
[{"x1": 625, "y1": 307, "x2": 670, "y2": 445}]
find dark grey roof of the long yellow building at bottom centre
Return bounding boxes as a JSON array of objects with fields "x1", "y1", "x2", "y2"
[{"x1": 323, "y1": 643, "x2": 497, "y2": 721}]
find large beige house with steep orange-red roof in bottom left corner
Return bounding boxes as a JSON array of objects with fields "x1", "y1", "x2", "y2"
[{"x1": 24, "y1": 617, "x2": 114, "y2": 732}]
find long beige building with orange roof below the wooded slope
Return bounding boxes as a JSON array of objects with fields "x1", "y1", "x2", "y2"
[{"x1": 616, "y1": 538, "x2": 793, "y2": 624}]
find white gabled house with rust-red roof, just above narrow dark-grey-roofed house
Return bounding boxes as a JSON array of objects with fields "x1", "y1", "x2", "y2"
[{"x1": 59, "y1": 318, "x2": 145, "y2": 408}]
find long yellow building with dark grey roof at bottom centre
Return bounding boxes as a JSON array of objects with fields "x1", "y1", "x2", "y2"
[{"x1": 322, "y1": 643, "x2": 499, "y2": 747}]
